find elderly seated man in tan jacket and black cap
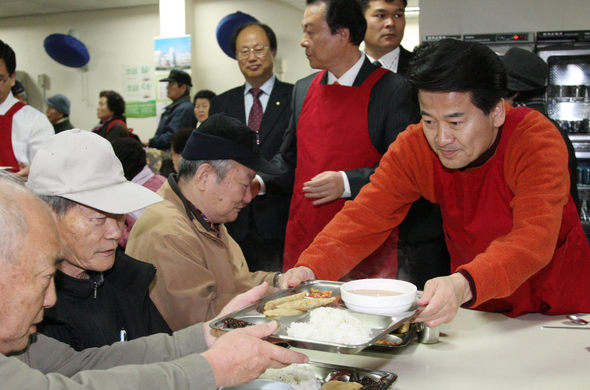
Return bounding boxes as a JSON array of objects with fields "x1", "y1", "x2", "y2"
[{"x1": 126, "y1": 114, "x2": 288, "y2": 330}]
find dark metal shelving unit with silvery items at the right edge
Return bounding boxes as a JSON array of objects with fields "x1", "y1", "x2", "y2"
[{"x1": 536, "y1": 30, "x2": 590, "y2": 237}]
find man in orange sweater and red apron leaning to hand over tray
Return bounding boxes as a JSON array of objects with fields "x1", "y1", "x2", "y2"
[{"x1": 283, "y1": 40, "x2": 590, "y2": 326}]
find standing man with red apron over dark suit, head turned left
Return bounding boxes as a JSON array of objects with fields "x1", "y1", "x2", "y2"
[{"x1": 261, "y1": 0, "x2": 426, "y2": 277}]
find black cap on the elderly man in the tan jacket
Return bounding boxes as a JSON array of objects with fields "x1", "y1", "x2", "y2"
[{"x1": 182, "y1": 113, "x2": 281, "y2": 174}]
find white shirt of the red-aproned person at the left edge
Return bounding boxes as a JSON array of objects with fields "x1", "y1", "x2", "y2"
[{"x1": 0, "y1": 92, "x2": 55, "y2": 165}]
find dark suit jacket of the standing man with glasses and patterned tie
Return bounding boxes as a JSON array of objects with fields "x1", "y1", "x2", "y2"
[{"x1": 209, "y1": 80, "x2": 293, "y2": 241}]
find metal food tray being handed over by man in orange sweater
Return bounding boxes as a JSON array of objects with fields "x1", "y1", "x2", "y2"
[{"x1": 210, "y1": 280, "x2": 415, "y2": 354}]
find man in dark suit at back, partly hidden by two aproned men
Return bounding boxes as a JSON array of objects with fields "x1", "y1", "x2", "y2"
[{"x1": 358, "y1": 0, "x2": 450, "y2": 288}]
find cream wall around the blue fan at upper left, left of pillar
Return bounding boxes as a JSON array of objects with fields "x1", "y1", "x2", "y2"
[{"x1": 0, "y1": 6, "x2": 159, "y2": 140}]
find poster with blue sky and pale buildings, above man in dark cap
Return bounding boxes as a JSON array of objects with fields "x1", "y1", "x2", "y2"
[{"x1": 154, "y1": 35, "x2": 191, "y2": 116}]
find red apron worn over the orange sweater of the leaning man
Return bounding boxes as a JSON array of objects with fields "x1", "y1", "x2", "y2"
[{"x1": 434, "y1": 107, "x2": 590, "y2": 317}]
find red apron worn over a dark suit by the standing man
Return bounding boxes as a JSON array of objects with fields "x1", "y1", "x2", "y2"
[{"x1": 283, "y1": 68, "x2": 397, "y2": 275}]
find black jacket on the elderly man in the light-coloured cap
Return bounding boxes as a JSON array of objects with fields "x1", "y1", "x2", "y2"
[{"x1": 38, "y1": 250, "x2": 171, "y2": 351}]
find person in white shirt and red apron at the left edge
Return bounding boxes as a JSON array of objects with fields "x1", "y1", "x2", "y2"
[{"x1": 0, "y1": 40, "x2": 54, "y2": 176}]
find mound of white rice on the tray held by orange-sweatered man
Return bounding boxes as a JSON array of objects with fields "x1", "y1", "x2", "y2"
[{"x1": 287, "y1": 307, "x2": 372, "y2": 345}]
